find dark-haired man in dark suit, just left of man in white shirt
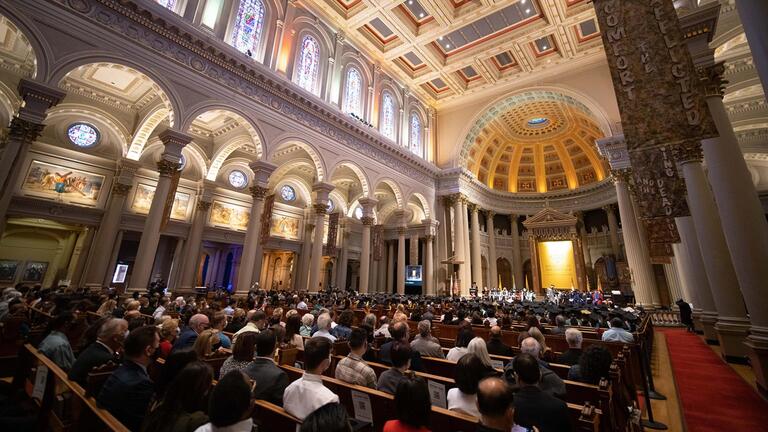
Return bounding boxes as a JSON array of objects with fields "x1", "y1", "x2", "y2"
[{"x1": 245, "y1": 330, "x2": 290, "y2": 406}]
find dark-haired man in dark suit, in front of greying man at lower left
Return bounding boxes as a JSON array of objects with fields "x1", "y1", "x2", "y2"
[{"x1": 96, "y1": 326, "x2": 160, "y2": 430}]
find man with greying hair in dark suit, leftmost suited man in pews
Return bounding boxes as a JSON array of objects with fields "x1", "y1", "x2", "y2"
[{"x1": 67, "y1": 318, "x2": 128, "y2": 387}]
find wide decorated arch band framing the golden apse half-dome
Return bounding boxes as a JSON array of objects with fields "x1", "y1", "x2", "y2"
[{"x1": 454, "y1": 86, "x2": 612, "y2": 167}]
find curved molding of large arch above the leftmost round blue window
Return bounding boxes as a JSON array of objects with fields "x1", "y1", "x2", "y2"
[{"x1": 49, "y1": 52, "x2": 184, "y2": 127}]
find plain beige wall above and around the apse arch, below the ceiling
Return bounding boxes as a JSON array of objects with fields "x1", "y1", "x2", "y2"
[{"x1": 435, "y1": 59, "x2": 620, "y2": 168}]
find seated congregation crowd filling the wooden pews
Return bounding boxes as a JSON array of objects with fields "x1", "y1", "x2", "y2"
[{"x1": 0, "y1": 287, "x2": 637, "y2": 432}]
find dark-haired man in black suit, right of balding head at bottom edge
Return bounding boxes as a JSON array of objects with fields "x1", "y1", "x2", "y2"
[{"x1": 512, "y1": 354, "x2": 571, "y2": 432}]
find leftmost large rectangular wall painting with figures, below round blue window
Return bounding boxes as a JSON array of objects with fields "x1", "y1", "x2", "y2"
[{"x1": 21, "y1": 160, "x2": 104, "y2": 207}]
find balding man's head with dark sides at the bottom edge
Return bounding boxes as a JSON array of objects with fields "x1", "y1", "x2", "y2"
[{"x1": 477, "y1": 377, "x2": 515, "y2": 432}]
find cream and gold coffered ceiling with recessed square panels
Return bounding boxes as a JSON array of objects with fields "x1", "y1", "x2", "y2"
[{"x1": 303, "y1": 0, "x2": 602, "y2": 106}]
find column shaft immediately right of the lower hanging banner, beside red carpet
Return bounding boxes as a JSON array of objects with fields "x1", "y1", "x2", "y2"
[{"x1": 675, "y1": 216, "x2": 718, "y2": 344}]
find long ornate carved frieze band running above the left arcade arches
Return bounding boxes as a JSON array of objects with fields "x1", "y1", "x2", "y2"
[{"x1": 48, "y1": 0, "x2": 439, "y2": 186}]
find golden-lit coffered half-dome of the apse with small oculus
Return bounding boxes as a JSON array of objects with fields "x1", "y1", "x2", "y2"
[{"x1": 466, "y1": 98, "x2": 607, "y2": 193}]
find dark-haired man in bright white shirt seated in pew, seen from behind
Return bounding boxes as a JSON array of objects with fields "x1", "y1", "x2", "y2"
[{"x1": 283, "y1": 338, "x2": 339, "y2": 420}]
